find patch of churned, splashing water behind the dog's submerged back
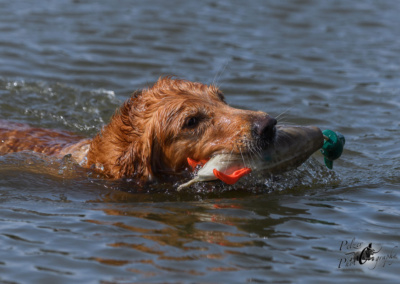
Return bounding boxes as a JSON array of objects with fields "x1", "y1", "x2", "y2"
[{"x1": 0, "y1": 80, "x2": 121, "y2": 135}]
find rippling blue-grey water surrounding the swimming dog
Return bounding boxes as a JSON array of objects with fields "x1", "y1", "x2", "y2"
[{"x1": 0, "y1": 0, "x2": 400, "y2": 283}]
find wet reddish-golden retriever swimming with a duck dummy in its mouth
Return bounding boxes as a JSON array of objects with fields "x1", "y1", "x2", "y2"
[{"x1": 0, "y1": 77, "x2": 277, "y2": 180}]
